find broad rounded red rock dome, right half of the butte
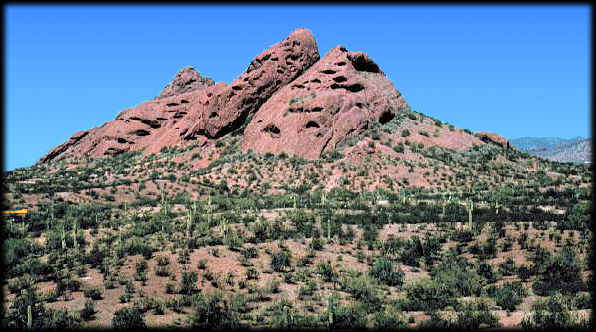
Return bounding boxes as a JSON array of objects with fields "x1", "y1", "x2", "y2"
[{"x1": 242, "y1": 46, "x2": 409, "y2": 159}]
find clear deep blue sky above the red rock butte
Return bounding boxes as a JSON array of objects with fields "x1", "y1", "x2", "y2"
[{"x1": 4, "y1": 5, "x2": 591, "y2": 170}]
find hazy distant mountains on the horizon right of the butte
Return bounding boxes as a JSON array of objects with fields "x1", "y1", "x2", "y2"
[{"x1": 510, "y1": 136, "x2": 592, "y2": 163}]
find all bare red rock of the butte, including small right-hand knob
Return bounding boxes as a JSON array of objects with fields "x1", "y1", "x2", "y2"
[{"x1": 39, "y1": 28, "x2": 498, "y2": 163}]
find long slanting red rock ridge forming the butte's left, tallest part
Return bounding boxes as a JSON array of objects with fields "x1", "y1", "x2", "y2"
[{"x1": 40, "y1": 29, "x2": 319, "y2": 162}]
